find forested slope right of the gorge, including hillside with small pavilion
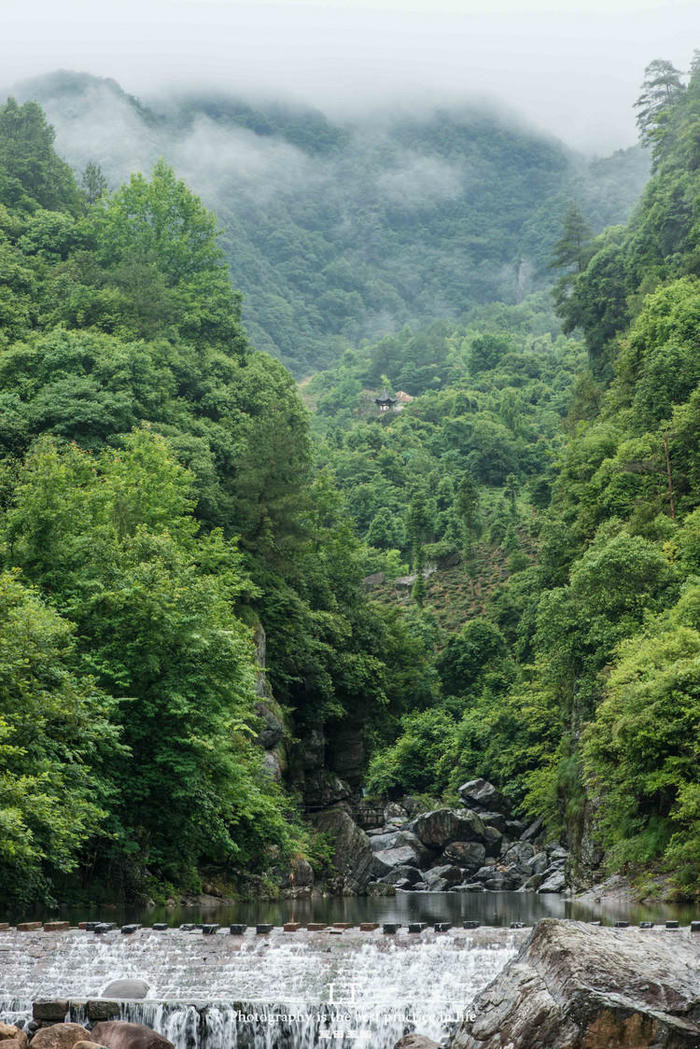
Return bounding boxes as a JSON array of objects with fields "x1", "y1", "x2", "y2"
[{"x1": 309, "y1": 55, "x2": 700, "y2": 894}]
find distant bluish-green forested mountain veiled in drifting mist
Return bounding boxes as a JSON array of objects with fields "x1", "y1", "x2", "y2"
[{"x1": 9, "y1": 73, "x2": 648, "y2": 378}]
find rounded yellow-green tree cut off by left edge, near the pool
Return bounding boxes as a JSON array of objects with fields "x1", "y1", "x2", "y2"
[{"x1": 0, "y1": 571, "x2": 117, "y2": 905}]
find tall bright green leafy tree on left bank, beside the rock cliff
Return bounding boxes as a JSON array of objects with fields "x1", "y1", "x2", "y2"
[{"x1": 5, "y1": 430, "x2": 304, "y2": 883}]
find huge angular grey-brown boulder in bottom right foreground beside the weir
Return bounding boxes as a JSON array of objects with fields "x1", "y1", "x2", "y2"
[{"x1": 448, "y1": 918, "x2": 700, "y2": 1049}]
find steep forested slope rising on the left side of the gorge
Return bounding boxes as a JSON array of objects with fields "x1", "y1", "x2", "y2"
[{"x1": 0, "y1": 100, "x2": 428, "y2": 906}]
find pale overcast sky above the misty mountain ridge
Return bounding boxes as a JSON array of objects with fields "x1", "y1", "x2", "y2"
[{"x1": 0, "y1": 0, "x2": 700, "y2": 153}]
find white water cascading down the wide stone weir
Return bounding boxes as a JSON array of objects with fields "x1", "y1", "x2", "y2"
[{"x1": 0, "y1": 928, "x2": 527, "y2": 1049}]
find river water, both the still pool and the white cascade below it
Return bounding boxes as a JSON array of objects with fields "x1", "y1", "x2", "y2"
[{"x1": 0, "y1": 893, "x2": 697, "y2": 1049}]
